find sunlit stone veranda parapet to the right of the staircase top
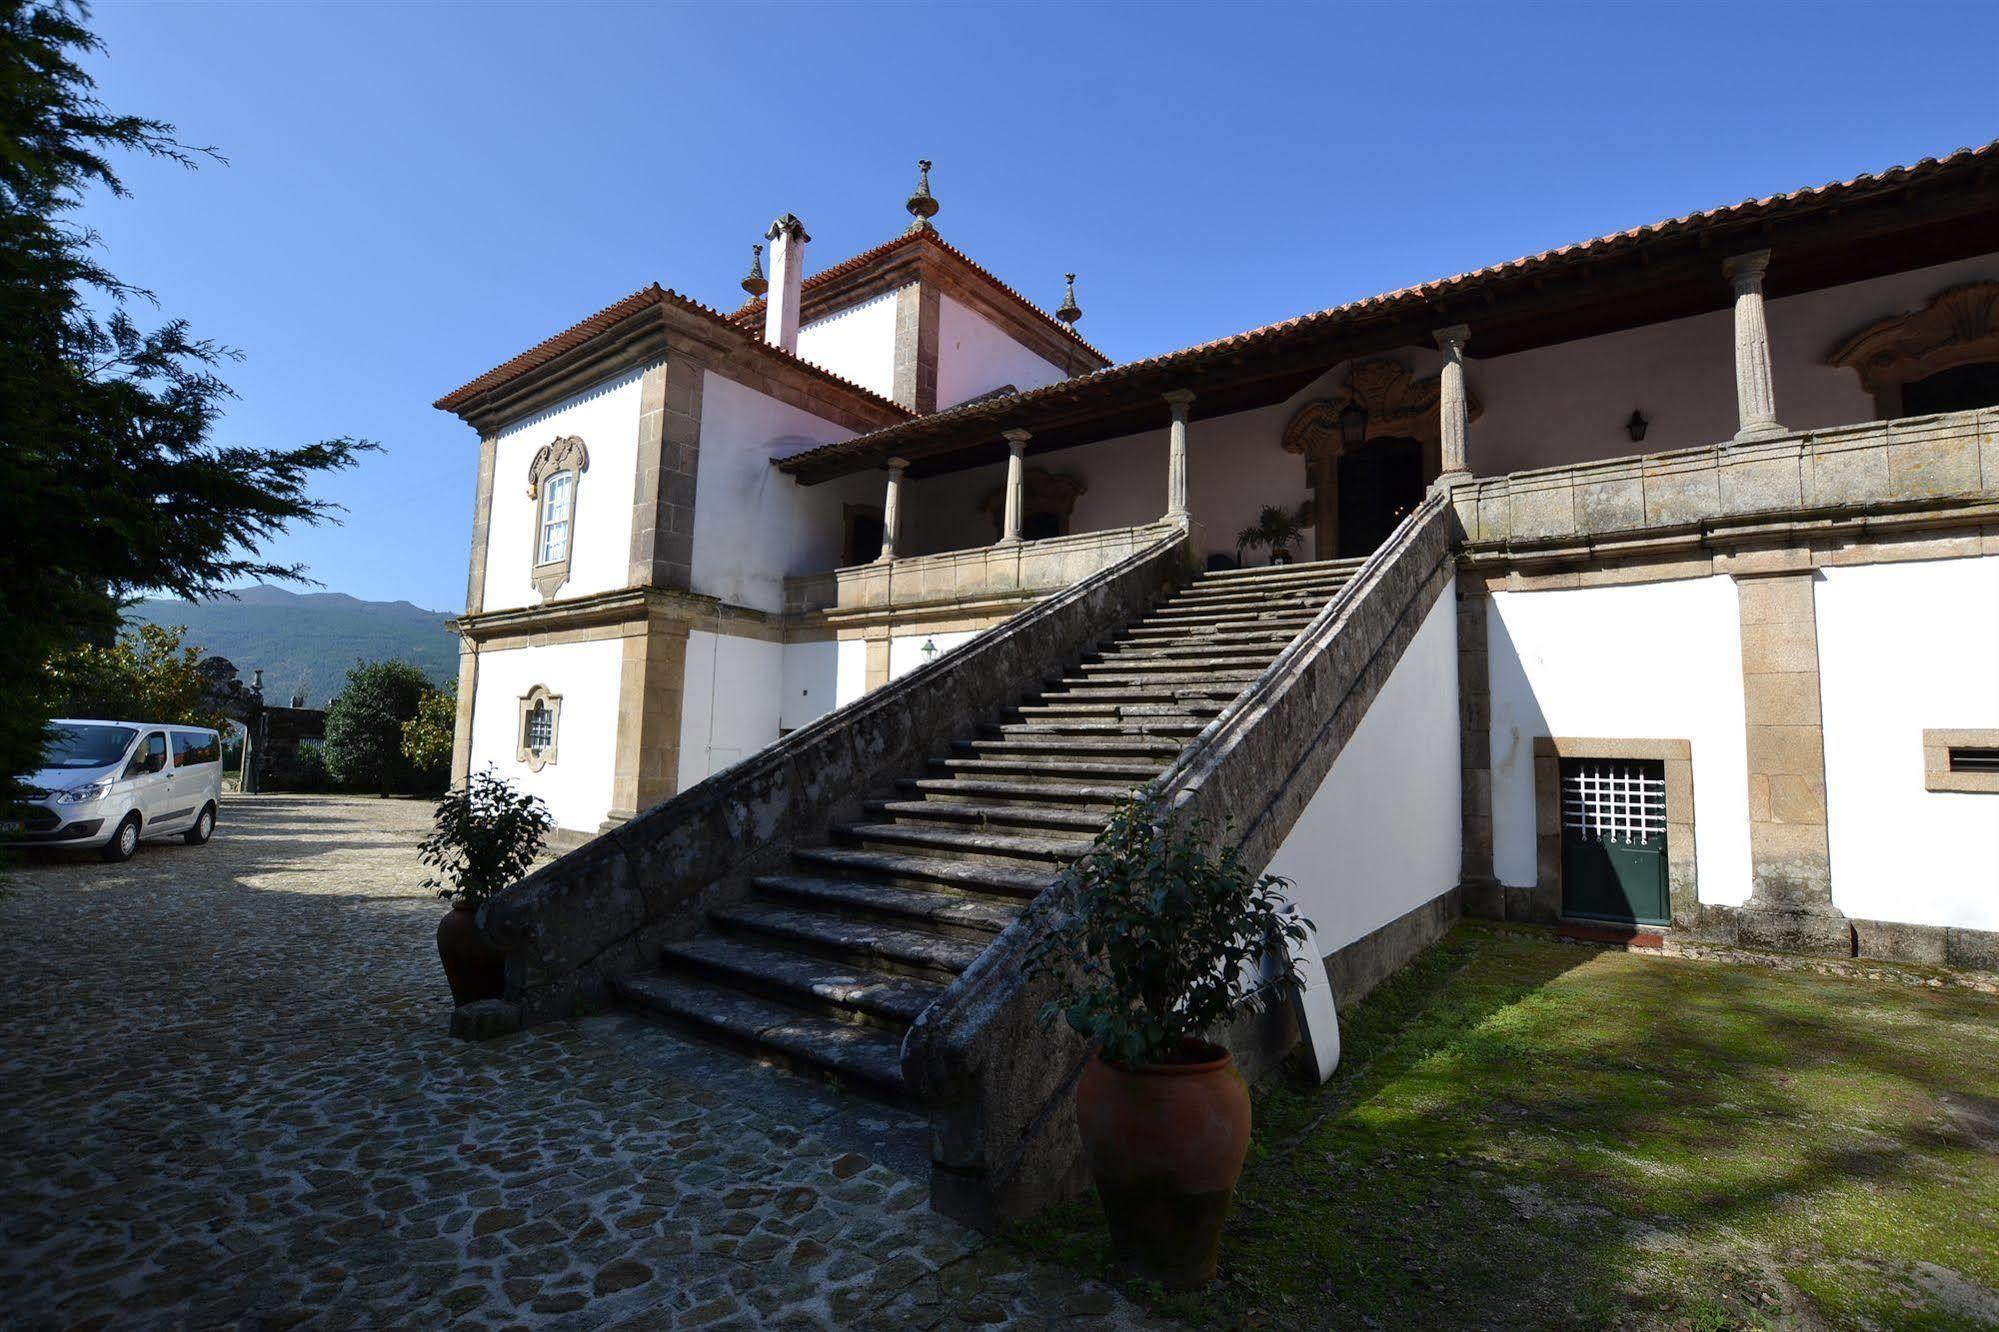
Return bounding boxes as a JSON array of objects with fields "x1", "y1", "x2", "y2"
[{"x1": 1451, "y1": 408, "x2": 1999, "y2": 548}]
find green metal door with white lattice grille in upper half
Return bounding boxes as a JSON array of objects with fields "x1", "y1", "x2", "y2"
[{"x1": 1561, "y1": 758, "x2": 1673, "y2": 924}]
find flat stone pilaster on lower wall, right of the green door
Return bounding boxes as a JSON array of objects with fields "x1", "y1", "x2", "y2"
[{"x1": 1735, "y1": 562, "x2": 1853, "y2": 954}]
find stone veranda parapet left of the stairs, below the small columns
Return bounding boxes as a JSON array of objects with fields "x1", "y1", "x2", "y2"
[{"x1": 784, "y1": 524, "x2": 1177, "y2": 618}]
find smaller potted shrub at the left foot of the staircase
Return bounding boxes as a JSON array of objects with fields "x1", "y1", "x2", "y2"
[{"x1": 418, "y1": 768, "x2": 554, "y2": 1004}]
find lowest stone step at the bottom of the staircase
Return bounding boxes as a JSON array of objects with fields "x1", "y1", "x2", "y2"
[{"x1": 612, "y1": 972, "x2": 908, "y2": 1102}]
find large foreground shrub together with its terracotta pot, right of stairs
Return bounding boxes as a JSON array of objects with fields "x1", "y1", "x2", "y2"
[{"x1": 1029, "y1": 794, "x2": 1305, "y2": 1290}]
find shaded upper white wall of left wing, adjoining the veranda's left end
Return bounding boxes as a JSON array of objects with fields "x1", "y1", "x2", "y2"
[{"x1": 694, "y1": 372, "x2": 886, "y2": 610}]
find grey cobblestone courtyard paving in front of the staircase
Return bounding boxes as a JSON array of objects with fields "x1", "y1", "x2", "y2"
[{"x1": 0, "y1": 796, "x2": 1167, "y2": 1328}]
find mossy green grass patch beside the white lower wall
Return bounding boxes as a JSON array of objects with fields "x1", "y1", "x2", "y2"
[{"x1": 1007, "y1": 926, "x2": 1999, "y2": 1328}]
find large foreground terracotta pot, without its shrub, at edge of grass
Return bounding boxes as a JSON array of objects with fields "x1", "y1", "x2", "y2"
[{"x1": 1075, "y1": 1042, "x2": 1249, "y2": 1290}]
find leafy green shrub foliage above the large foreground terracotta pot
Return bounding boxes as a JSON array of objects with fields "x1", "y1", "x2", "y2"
[{"x1": 1029, "y1": 794, "x2": 1307, "y2": 1066}]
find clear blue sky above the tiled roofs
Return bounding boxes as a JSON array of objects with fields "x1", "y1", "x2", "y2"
[{"x1": 86, "y1": 2, "x2": 1999, "y2": 610}]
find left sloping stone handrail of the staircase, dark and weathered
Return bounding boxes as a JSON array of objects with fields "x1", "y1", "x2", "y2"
[{"x1": 480, "y1": 528, "x2": 1191, "y2": 1022}]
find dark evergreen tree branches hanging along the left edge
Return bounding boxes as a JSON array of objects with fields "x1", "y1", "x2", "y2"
[{"x1": 0, "y1": 0, "x2": 372, "y2": 784}]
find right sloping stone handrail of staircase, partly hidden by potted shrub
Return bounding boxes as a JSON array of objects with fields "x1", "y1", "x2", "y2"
[{"x1": 902, "y1": 496, "x2": 1453, "y2": 1228}]
